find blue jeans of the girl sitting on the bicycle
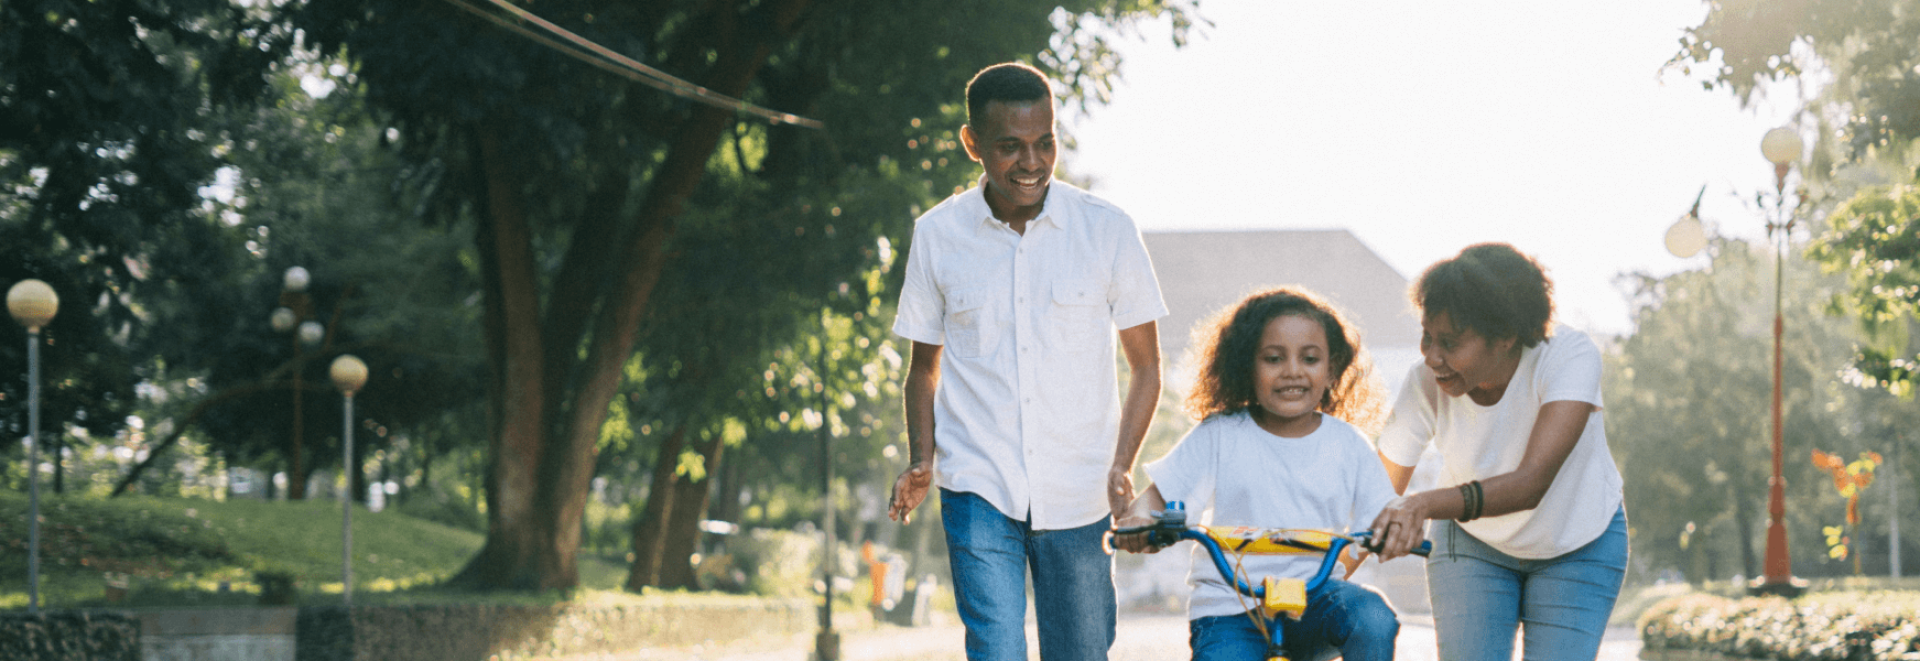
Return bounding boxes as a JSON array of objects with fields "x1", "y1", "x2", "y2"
[{"x1": 1187, "y1": 580, "x2": 1400, "y2": 661}]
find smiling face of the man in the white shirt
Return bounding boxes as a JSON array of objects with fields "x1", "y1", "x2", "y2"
[{"x1": 960, "y1": 98, "x2": 1058, "y2": 223}]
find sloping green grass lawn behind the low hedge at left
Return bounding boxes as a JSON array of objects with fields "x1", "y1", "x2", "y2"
[{"x1": 0, "y1": 492, "x2": 626, "y2": 609}]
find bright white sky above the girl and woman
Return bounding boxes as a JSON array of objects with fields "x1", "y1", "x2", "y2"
[{"x1": 1062, "y1": 0, "x2": 1799, "y2": 332}]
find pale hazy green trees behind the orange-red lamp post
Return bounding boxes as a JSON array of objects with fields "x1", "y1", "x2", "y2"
[{"x1": 1603, "y1": 238, "x2": 1920, "y2": 582}]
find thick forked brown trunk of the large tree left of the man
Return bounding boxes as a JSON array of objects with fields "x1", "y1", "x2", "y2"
[{"x1": 455, "y1": 0, "x2": 808, "y2": 590}]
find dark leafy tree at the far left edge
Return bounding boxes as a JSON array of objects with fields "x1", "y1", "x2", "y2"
[{"x1": 0, "y1": 0, "x2": 278, "y2": 489}]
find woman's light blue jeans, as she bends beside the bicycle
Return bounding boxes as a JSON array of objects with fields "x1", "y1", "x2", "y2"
[{"x1": 1427, "y1": 507, "x2": 1626, "y2": 661}]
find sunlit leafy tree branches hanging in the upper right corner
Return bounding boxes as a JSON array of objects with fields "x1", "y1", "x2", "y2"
[{"x1": 1672, "y1": 0, "x2": 1920, "y2": 396}]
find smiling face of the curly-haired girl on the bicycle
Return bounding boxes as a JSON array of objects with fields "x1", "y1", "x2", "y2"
[{"x1": 1254, "y1": 315, "x2": 1332, "y2": 438}]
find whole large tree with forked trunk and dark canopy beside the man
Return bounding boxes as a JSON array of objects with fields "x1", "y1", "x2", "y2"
[{"x1": 288, "y1": 0, "x2": 1185, "y2": 590}]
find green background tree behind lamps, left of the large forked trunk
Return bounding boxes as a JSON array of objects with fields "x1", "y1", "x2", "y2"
[{"x1": 94, "y1": 56, "x2": 480, "y2": 500}]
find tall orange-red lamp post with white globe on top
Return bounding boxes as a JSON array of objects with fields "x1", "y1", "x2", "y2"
[{"x1": 1749, "y1": 127, "x2": 1805, "y2": 598}]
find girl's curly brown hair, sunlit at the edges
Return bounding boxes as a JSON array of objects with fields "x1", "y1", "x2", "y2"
[{"x1": 1187, "y1": 286, "x2": 1386, "y2": 436}]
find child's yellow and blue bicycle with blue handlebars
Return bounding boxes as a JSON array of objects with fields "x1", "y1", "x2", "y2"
[{"x1": 1104, "y1": 500, "x2": 1432, "y2": 661}]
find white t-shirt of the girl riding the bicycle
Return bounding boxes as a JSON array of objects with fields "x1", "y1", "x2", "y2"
[{"x1": 1146, "y1": 411, "x2": 1394, "y2": 619}]
